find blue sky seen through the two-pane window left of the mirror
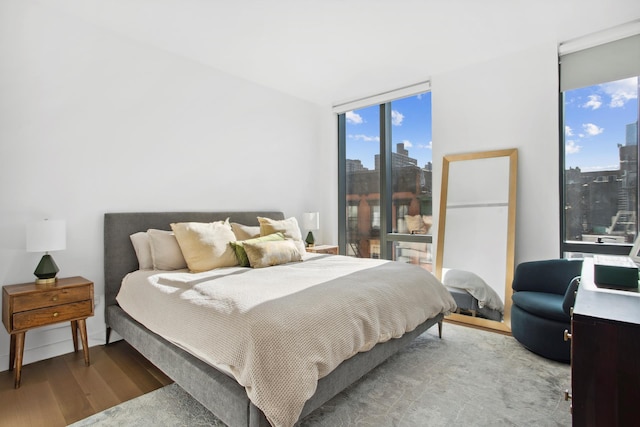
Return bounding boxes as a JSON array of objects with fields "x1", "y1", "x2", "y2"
[{"x1": 346, "y1": 92, "x2": 433, "y2": 170}]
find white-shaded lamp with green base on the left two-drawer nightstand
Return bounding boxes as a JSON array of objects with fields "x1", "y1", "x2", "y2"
[{"x1": 27, "y1": 219, "x2": 67, "y2": 284}]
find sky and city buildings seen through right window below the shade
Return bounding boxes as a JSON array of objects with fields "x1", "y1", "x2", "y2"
[{"x1": 563, "y1": 77, "x2": 639, "y2": 243}]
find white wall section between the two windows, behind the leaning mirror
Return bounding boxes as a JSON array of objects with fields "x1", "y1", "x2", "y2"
[{"x1": 432, "y1": 43, "x2": 560, "y2": 264}]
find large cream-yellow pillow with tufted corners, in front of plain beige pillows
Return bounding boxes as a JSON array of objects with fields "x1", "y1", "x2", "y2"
[{"x1": 171, "y1": 219, "x2": 238, "y2": 273}]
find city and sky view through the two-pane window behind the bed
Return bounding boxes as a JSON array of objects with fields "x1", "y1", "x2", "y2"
[{"x1": 345, "y1": 92, "x2": 433, "y2": 269}]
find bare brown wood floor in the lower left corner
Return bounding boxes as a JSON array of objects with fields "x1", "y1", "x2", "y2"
[{"x1": 0, "y1": 341, "x2": 172, "y2": 427}]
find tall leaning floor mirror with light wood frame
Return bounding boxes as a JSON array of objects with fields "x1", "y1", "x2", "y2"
[{"x1": 435, "y1": 149, "x2": 518, "y2": 332}]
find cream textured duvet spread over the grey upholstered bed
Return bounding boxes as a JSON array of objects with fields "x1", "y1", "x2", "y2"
[{"x1": 117, "y1": 255, "x2": 456, "y2": 426}]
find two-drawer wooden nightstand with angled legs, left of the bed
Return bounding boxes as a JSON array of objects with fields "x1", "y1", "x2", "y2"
[{"x1": 2, "y1": 277, "x2": 93, "y2": 388}]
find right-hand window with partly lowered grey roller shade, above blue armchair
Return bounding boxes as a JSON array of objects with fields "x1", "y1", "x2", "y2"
[{"x1": 560, "y1": 35, "x2": 640, "y2": 255}]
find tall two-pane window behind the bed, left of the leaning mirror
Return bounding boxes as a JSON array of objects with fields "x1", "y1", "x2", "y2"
[{"x1": 338, "y1": 85, "x2": 433, "y2": 269}]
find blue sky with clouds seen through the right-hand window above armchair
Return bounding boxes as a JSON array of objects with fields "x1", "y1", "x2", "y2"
[{"x1": 564, "y1": 77, "x2": 638, "y2": 172}]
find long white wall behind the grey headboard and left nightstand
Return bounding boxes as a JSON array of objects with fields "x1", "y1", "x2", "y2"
[{"x1": 0, "y1": 2, "x2": 336, "y2": 375}]
